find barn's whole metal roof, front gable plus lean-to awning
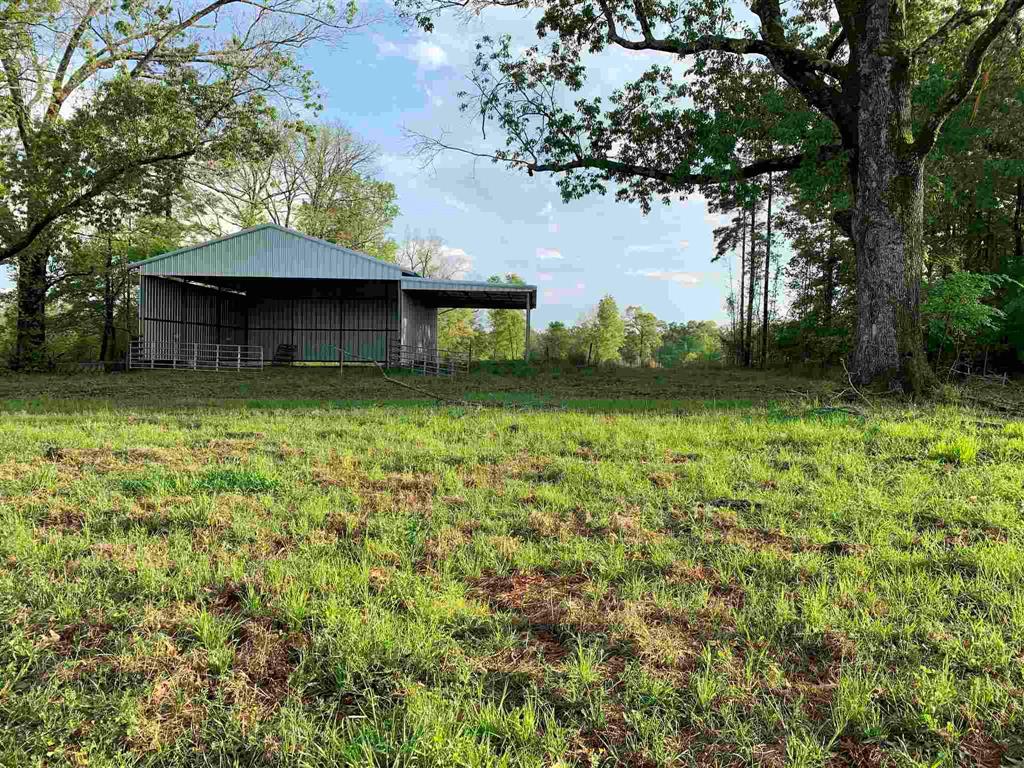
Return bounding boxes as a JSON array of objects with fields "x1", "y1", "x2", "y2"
[{"x1": 131, "y1": 224, "x2": 537, "y2": 309}]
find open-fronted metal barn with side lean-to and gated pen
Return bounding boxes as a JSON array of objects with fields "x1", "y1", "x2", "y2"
[{"x1": 129, "y1": 224, "x2": 537, "y2": 369}]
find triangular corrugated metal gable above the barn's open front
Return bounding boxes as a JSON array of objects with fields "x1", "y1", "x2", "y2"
[{"x1": 132, "y1": 224, "x2": 415, "y2": 280}]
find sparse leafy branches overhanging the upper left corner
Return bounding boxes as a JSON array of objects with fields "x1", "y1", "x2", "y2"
[{"x1": 0, "y1": 0, "x2": 380, "y2": 262}]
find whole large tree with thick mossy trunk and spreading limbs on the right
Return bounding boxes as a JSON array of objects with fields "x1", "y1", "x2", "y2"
[{"x1": 406, "y1": 0, "x2": 1024, "y2": 391}]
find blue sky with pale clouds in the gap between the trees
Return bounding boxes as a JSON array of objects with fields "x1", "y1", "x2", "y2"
[{"x1": 306, "y1": 10, "x2": 728, "y2": 328}]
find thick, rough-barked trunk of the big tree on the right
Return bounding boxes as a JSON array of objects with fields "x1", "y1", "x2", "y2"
[{"x1": 851, "y1": 0, "x2": 937, "y2": 394}]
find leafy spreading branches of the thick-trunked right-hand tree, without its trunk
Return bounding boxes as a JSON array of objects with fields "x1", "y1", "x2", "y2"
[{"x1": 402, "y1": 0, "x2": 1024, "y2": 208}]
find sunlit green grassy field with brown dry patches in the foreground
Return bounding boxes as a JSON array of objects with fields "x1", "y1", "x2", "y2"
[{"x1": 0, "y1": 369, "x2": 1024, "y2": 768}]
